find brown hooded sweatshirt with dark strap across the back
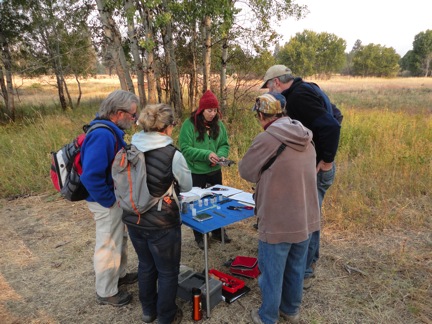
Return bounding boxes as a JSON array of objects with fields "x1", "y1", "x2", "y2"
[{"x1": 239, "y1": 117, "x2": 320, "y2": 244}]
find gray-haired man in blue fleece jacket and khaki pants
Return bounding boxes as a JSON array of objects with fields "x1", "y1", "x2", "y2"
[{"x1": 81, "y1": 90, "x2": 139, "y2": 306}]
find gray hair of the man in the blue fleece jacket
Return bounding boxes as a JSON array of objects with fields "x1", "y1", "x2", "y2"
[{"x1": 98, "y1": 90, "x2": 139, "y2": 119}]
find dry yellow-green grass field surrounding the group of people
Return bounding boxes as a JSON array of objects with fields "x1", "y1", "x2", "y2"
[{"x1": 0, "y1": 77, "x2": 432, "y2": 323}]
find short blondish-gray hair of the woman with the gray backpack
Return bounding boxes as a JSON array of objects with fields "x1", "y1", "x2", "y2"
[{"x1": 138, "y1": 103, "x2": 174, "y2": 132}]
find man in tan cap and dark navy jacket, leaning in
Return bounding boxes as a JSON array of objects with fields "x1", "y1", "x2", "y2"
[{"x1": 261, "y1": 65, "x2": 340, "y2": 289}]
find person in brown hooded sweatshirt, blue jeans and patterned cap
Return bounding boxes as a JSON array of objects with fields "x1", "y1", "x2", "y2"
[{"x1": 239, "y1": 92, "x2": 320, "y2": 324}]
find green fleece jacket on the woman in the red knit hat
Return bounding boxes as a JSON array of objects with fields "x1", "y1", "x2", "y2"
[{"x1": 178, "y1": 119, "x2": 229, "y2": 174}]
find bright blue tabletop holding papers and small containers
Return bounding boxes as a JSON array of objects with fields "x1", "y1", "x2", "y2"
[{"x1": 181, "y1": 197, "x2": 254, "y2": 234}]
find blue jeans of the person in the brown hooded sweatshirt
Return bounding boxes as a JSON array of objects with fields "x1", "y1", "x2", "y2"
[{"x1": 258, "y1": 238, "x2": 309, "y2": 324}]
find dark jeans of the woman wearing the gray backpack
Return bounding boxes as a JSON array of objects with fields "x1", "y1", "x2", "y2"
[{"x1": 128, "y1": 225, "x2": 181, "y2": 324}]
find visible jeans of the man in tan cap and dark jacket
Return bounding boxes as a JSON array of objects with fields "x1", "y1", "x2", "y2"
[{"x1": 305, "y1": 162, "x2": 336, "y2": 278}]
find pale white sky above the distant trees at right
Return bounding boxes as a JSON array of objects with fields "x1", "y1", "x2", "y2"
[{"x1": 276, "y1": 0, "x2": 432, "y2": 57}]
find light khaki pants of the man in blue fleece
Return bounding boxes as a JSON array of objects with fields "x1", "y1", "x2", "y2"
[{"x1": 87, "y1": 202, "x2": 127, "y2": 297}]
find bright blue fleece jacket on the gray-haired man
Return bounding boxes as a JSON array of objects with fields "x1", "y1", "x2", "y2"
[{"x1": 81, "y1": 119, "x2": 126, "y2": 208}]
